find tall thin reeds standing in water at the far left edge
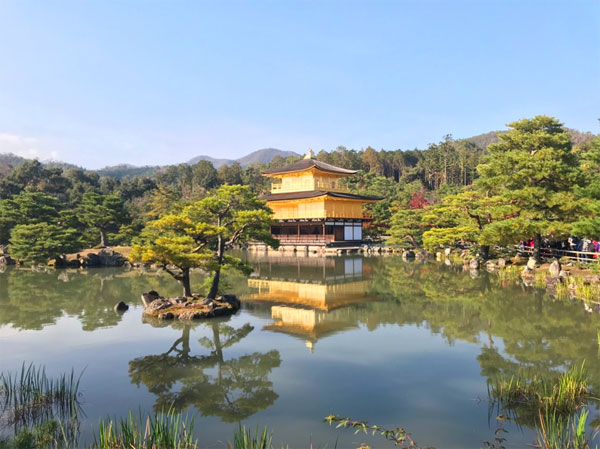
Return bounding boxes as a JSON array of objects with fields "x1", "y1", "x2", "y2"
[{"x1": 0, "y1": 363, "x2": 81, "y2": 427}]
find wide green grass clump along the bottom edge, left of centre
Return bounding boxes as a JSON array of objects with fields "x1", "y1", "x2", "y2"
[{"x1": 92, "y1": 409, "x2": 198, "y2": 449}]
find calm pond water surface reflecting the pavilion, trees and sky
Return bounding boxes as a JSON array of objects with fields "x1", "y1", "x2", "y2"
[{"x1": 0, "y1": 253, "x2": 600, "y2": 448}]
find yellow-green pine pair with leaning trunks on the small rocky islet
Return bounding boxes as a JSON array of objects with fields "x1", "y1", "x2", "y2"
[{"x1": 131, "y1": 185, "x2": 279, "y2": 299}]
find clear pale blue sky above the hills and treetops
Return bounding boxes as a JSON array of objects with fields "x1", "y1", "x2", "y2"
[{"x1": 0, "y1": 0, "x2": 600, "y2": 168}]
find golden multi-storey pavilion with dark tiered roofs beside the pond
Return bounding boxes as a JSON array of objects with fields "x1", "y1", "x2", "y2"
[{"x1": 260, "y1": 150, "x2": 381, "y2": 246}]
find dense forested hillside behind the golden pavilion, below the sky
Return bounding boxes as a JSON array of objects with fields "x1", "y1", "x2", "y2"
[{"x1": 0, "y1": 120, "x2": 598, "y2": 260}]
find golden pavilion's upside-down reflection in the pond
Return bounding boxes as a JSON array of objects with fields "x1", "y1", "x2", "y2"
[{"x1": 244, "y1": 256, "x2": 375, "y2": 351}]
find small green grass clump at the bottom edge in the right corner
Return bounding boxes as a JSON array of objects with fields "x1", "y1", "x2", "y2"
[{"x1": 536, "y1": 409, "x2": 597, "y2": 449}]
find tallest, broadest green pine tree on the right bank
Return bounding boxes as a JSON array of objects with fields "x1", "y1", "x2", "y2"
[{"x1": 477, "y1": 115, "x2": 589, "y2": 260}]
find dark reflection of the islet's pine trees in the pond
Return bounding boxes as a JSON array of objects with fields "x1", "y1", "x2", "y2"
[{"x1": 129, "y1": 320, "x2": 281, "y2": 422}]
